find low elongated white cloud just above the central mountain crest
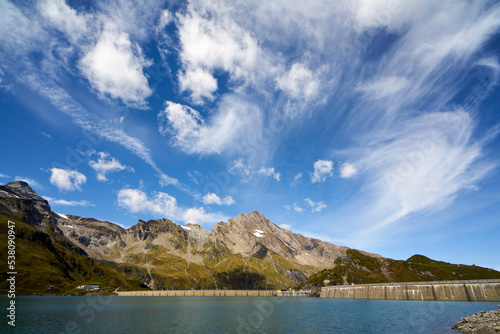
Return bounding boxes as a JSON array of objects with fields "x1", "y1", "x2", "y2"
[{"x1": 118, "y1": 188, "x2": 226, "y2": 224}]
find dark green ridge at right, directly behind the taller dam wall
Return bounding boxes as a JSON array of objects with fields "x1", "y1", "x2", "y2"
[{"x1": 302, "y1": 249, "x2": 500, "y2": 286}]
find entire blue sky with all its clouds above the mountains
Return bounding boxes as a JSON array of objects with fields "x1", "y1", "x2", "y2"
[{"x1": 0, "y1": 0, "x2": 500, "y2": 270}]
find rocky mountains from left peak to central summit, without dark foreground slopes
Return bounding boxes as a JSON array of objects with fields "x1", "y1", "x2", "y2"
[{"x1": 0, "y1": 182, "x2": 378, "y2": 289}]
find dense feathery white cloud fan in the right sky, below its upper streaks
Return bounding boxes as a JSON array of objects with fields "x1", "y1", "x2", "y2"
[{"x1": 359, "y1": 111, "x2": 497, "y2": 232}]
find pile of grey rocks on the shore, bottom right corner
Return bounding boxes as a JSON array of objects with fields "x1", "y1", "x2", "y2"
[{"x1": 453, "y1": 305, "x2": 500, "y2": 333}]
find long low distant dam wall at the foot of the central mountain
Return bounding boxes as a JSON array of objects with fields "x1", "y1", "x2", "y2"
[{"x1": 116, "y1": 290, "x2": 309, "y2": 297}]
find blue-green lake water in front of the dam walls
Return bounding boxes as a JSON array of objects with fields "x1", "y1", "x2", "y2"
[{"x1": 0, "y1": 296, "x2": 498, "y2": 334}]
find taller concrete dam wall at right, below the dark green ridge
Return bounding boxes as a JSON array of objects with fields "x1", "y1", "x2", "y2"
[{"x1": 320, "y1": 280, "x2": 500, "y2": 302}]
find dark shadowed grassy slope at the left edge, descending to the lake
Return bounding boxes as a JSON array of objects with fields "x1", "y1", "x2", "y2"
[{"x1": 0, "y1": 213, "x2": 148, "y2": 295}]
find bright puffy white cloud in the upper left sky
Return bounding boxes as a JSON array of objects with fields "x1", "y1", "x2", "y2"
[{"x1": 79, "y1": 26, "x2": 152, "y2": 107}]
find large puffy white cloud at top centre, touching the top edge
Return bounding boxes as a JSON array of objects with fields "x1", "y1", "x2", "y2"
[{"x1": 177, "y1": 3, "x2": 266, "y2": 103}]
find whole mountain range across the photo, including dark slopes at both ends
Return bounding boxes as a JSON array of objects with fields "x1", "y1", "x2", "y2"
[{"x1": 0, "y1": 181, "x2": 500, "y2": 294}]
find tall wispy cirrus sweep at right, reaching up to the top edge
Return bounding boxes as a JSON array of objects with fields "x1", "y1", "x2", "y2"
[{"x1": 334, "y1": 1, "x2": 500, "y2": 237}]
